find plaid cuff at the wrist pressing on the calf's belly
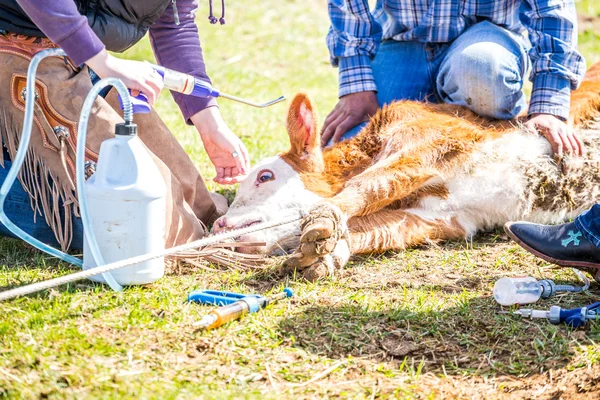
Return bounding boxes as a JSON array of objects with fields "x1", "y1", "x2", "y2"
[{"x1": 529, "y1": 74, "x2": 571, "y2": 120}]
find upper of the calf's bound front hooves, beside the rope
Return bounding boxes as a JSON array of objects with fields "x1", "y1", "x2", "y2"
[{"x1": 300, "y1": 203, "x2": 348, "y2": 257}]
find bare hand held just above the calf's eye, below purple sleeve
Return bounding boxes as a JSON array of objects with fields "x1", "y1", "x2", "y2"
[{"x1": 191, "y1": 107, "x2": 250, "y2": 185}]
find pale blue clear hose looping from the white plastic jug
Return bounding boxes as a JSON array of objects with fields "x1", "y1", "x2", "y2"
[{"x1": 0, "y1": 49, "x2": 126, "y2": 292}]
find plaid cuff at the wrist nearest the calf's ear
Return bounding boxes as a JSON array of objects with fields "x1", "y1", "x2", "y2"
[{"x1": 338, "y1": 55, "x2": 377, "y2": 97}]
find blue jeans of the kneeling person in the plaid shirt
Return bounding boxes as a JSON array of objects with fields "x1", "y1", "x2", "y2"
[{"x1": 342, "y1": 21, "x2": 530, "y2": 139}]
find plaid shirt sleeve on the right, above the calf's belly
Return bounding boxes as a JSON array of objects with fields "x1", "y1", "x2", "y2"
[{"x1": 521, "y1": 0, "x2": 585, "y2": 120}]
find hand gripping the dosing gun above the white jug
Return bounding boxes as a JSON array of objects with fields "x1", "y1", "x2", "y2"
[{"x1": 86, "y1": 50, "x2": 163, "y2": 106}]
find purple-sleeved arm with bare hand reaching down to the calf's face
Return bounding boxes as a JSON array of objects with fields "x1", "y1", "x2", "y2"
[{"x1": 150, "y1": 0, "x2": 250, "y2": 184}]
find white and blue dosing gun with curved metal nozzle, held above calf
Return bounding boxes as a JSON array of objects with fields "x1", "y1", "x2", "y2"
[{"x1": 124, "y1": 63, "x2": 285, "y2": 113}]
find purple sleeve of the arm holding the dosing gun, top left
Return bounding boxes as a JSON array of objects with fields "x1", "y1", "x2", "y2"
[{"x1": 17, "y1": 0, "x2": 104, "y2": 65}]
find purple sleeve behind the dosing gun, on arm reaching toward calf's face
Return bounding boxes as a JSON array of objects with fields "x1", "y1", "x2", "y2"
[{"x1": 150, "y1": 0, "x2": 217, "y2": 125}]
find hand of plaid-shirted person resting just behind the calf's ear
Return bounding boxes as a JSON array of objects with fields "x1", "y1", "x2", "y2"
[{"x1": 321, "y1": 92, "x2": 379, "y2": 147}]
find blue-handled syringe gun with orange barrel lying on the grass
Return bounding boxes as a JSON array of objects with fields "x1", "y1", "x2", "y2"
[{"x1": 188, "y1": 288, "x2": 294, "y2": 329}]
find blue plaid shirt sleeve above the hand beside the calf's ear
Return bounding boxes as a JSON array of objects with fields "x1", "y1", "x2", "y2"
[{"x1": 327, "y1": 0, "x2": 382, "y2": 97}]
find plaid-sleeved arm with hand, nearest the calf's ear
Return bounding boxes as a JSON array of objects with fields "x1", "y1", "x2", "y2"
[{"x1": 321, "y1": 0, "x2": 382, "y2": 145}]
